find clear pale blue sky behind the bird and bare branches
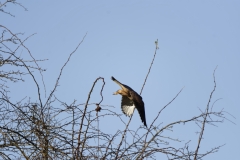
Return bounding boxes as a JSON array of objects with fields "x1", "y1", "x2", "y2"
[{"x1": 0, "y1": 0, "x2": 240, "y2": 160}]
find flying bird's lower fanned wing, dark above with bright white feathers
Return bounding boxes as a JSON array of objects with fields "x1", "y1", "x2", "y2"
[{"x1": 121, "y1": 96, "x2": 135, "y2": 116}]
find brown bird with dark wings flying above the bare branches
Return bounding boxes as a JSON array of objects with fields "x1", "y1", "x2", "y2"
[{"x1": 112, "y1": 77, "x2": 147, "y2": 127}]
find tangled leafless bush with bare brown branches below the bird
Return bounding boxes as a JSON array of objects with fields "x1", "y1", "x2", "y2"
[{"x1": 0, "y1": 1, "x2": 232, "y2": 160}]
